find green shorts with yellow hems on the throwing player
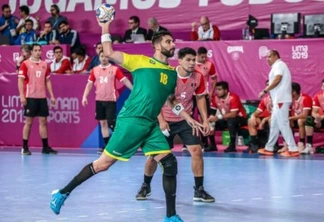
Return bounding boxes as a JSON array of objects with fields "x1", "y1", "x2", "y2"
[{"x1": 104, "y1": 118, "x2": 171, "y2": 161}]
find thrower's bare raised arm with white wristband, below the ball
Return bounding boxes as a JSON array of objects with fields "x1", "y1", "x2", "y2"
[{"x1": 98, "y1": 20, "x2": 124, "y2": 65}]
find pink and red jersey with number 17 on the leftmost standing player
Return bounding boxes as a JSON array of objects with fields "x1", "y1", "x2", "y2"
[{"x1": 18, "y1": 59, "x2": 50, "y2": 99}]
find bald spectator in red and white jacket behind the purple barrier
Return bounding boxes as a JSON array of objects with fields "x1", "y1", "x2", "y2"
[{"x1": 190, "y1": 16, "x2": 220, "y2": 41}]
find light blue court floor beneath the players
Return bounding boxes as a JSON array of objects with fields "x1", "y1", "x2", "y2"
[{"x1": 0, "y1": 149, "x2": 324, "y2": 222}]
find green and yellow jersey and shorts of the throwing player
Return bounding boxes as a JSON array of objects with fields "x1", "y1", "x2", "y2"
[{"x1": 105, "y1": 53, "x2": 177, "y2": 161}]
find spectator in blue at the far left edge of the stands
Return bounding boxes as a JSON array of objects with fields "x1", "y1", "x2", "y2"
[{"x1": 0, "y1": 4, "x2": 19, "y2": 45}]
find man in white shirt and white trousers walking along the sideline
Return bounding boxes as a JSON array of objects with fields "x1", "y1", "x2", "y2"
[{"x1": 258, "y1": 50, "x2": 299, "y2": 157}]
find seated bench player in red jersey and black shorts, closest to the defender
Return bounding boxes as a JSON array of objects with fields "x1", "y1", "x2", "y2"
[{"x1": 209, "y1": 81, "x2": 247, "y2": 153}]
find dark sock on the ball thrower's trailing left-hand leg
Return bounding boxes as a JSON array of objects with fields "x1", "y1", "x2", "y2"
[{"x1": 60, "y1": 163, "x2": 96, "y2": 194}]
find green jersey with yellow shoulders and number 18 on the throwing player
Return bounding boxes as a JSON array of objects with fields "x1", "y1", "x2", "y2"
[{"x1": 119, "y1": 53, "x2": 177, "y2": 124}]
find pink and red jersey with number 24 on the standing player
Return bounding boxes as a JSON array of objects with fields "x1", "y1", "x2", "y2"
[{"x1": 88, "y1": 64, "x2": 126, "y2": 101}]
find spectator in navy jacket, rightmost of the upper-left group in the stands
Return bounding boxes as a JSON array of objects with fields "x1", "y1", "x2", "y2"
[{"x1": 58, "y1": 21, "x2": 81, "y2": 52}]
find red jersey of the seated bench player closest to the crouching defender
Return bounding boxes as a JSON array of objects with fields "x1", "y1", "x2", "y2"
[{"x1": 211, "y1": 92, "x2": 246, "y2": 118}]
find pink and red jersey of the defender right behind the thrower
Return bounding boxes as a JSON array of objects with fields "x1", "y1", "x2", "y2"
[{"x1": 162, "y1": 72, "x2": 206, "y2": 122}]
